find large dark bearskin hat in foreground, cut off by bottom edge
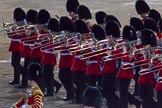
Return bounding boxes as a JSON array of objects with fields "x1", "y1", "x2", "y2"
[{"x1": 83, "y1": 87, "x2": 103, "y2": 108}]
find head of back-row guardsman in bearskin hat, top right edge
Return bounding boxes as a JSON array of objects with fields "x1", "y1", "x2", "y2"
[{"x1": 135, "y1": 0, "x2": 150, "y2": 22}]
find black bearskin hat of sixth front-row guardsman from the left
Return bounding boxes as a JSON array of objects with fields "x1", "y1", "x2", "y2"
[{"x1": 74, "y1": 20, "x2": 89, "y2": 33}]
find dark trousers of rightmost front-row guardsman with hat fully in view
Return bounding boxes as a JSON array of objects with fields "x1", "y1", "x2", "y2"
[{"x1": 140, "y1": 84, "x2": 157, "y2": 108}]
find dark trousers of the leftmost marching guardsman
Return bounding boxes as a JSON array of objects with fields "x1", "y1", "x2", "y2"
[{"x1": 11, "y1": 52, "x2": 23, "y2": 83}]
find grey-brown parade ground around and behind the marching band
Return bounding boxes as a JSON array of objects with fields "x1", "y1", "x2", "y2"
[{"x1": 0, "y1": 0, "x2": 162, "y2": 108}]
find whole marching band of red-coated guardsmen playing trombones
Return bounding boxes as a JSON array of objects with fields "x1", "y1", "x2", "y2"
[{"x1": 4, "y1": 0, "x2": 162, "y2": 108}]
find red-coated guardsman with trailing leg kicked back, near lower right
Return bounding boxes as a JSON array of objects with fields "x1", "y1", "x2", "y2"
[{"x1": 117, "y1": 25, "x2": 141, "y2": 108}]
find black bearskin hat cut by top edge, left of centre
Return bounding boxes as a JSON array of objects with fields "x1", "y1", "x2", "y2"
[{"x1": 66, "y1": 0, "x2": 79, "y2": 13}]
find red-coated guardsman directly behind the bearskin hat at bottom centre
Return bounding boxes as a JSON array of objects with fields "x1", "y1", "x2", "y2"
[{"x1": 85, "y1": 24, "x2": 105, "y2": 86}]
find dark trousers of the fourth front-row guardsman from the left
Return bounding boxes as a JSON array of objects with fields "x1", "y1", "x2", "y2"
[{"x1": 43, "y1": 65, "x2": 54, "y2": 94}]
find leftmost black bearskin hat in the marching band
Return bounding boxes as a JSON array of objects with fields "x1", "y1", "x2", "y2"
[{"x1": 13, "y1": 7, "x2": 26, "y2": 21}]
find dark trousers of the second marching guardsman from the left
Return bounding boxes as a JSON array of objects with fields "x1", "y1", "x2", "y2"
[{"x1": 22, "y1": 58, "x2": 31, "y2": 86}]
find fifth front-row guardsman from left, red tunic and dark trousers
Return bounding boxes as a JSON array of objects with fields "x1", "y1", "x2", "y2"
[{"x1": 59, "y1": 17, "x2": 74, "y2": 100}]
